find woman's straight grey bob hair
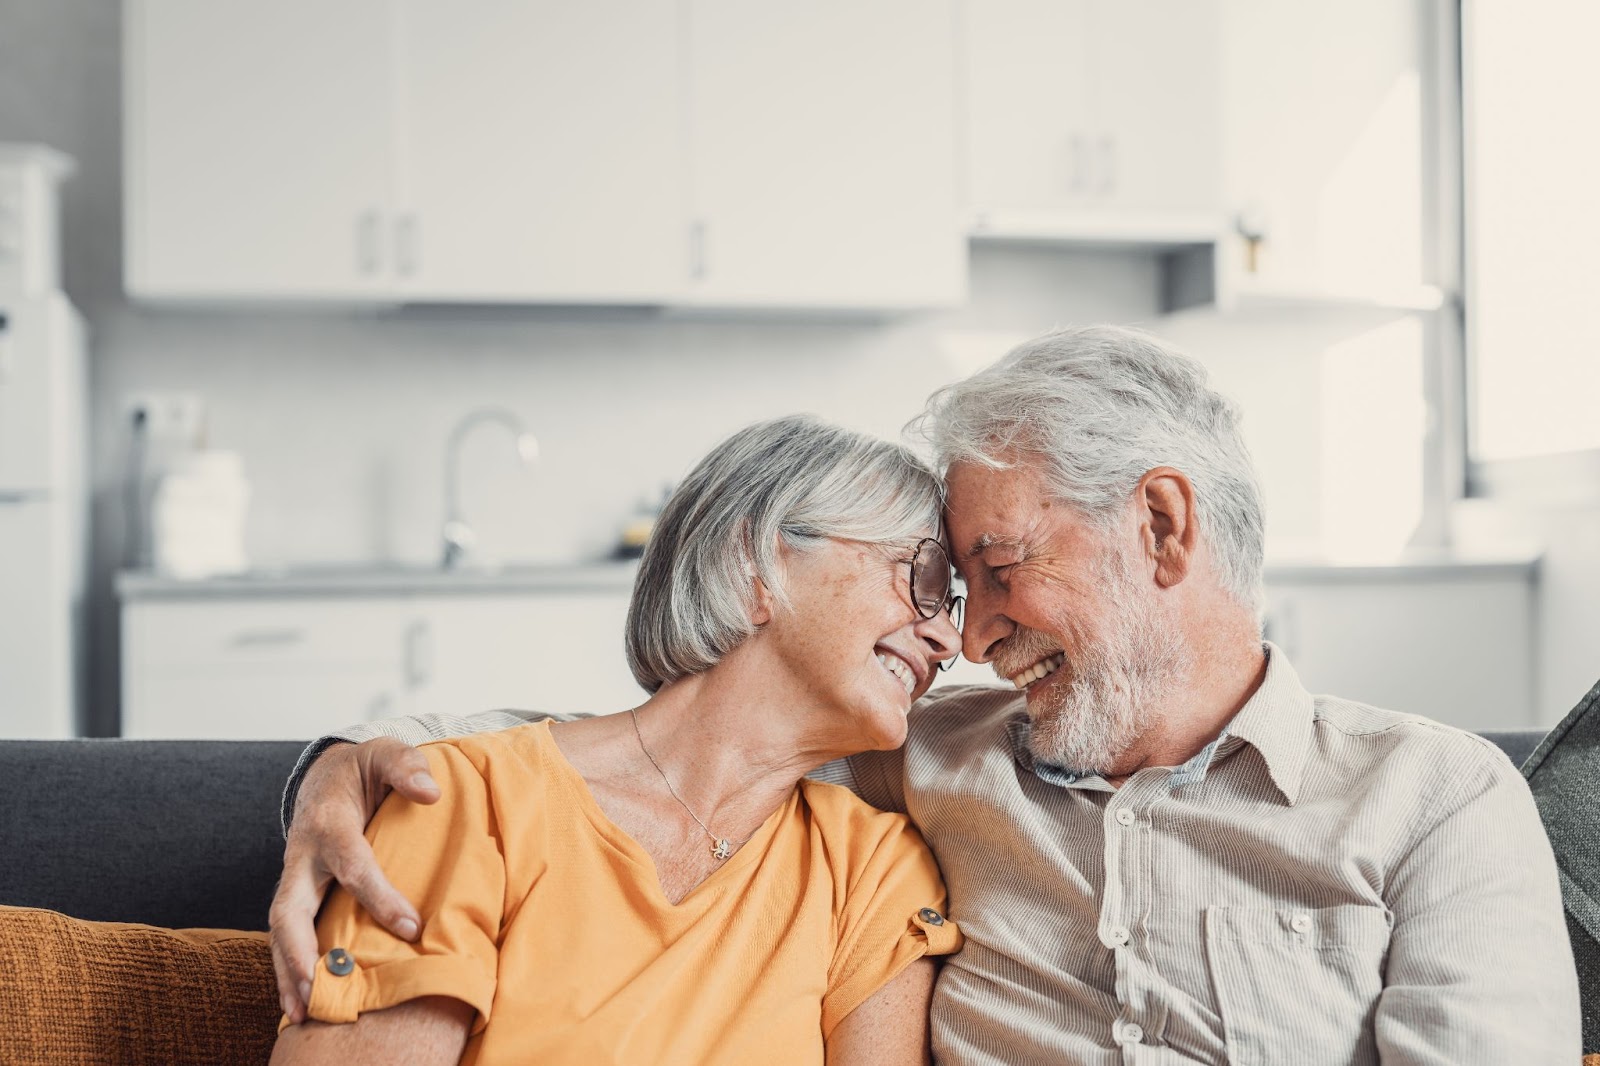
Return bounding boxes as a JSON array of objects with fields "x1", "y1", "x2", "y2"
[{"x1": 627, "y1": 415, "x2": 944, "y2": 693}]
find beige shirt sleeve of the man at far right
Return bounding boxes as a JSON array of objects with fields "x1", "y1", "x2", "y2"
[{"x1": 1374, "y1": 739, "x2": 1581, "y2": 1066}]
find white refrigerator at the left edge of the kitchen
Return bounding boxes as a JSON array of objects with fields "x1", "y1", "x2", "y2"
[{"x1": 0, "y1": 146, "x2": 88, "y2": 738}]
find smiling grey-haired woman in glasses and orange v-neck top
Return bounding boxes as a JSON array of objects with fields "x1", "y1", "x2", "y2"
[{"x1": 272, "y1": 418, "x2": 960, "y2": 1066}]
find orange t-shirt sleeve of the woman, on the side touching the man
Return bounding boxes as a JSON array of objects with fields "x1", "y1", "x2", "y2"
[{"x1": 822, "y1": 800, "x2": 962, "y2": 1039}]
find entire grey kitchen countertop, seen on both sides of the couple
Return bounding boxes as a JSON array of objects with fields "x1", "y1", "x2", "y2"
[{"x1": 117, "y1": 547, "x2": 1541, "y2": 602}]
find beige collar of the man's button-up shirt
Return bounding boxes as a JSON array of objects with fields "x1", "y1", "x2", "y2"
[{"x1": 1006, "y1": 633, "x2": 1315, "y2": 807}]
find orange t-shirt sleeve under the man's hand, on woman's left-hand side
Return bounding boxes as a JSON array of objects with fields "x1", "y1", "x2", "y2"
[{"x1": 292, "y1": 743, "x2": 506, "y2": 1032}]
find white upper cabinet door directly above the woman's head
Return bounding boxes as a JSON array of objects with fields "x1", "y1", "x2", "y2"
[{"x1": 690, "y1": 0, "x2": 966, "y2": 307}]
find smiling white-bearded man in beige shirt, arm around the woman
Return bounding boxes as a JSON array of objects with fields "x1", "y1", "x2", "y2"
[{"x1": 274, "y1": 328, "x2": 1579, "y2": 1066}]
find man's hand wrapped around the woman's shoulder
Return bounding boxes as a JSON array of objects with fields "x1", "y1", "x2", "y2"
[{"x1": 269, "y1": 736, "x2": 438, "y2": 1024}]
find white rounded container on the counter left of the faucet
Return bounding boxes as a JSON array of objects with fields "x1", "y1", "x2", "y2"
[{"x1": 150, "y1": 451, "x2": 250, "y2": 579}]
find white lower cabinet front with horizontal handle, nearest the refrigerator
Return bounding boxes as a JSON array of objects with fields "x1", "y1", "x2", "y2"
[{"x1": 122, "y1": 599, "x2": 416, "y2": 739}]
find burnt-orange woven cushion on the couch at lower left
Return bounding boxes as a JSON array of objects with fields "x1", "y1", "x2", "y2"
[{"x1": 0, "y1": 906, "x2": 278, "y2": 1066}]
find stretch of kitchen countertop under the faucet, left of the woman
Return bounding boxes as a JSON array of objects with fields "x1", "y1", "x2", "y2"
[{"x1": 117, "y1": 560, "x2": 638, "y2": 602}]
